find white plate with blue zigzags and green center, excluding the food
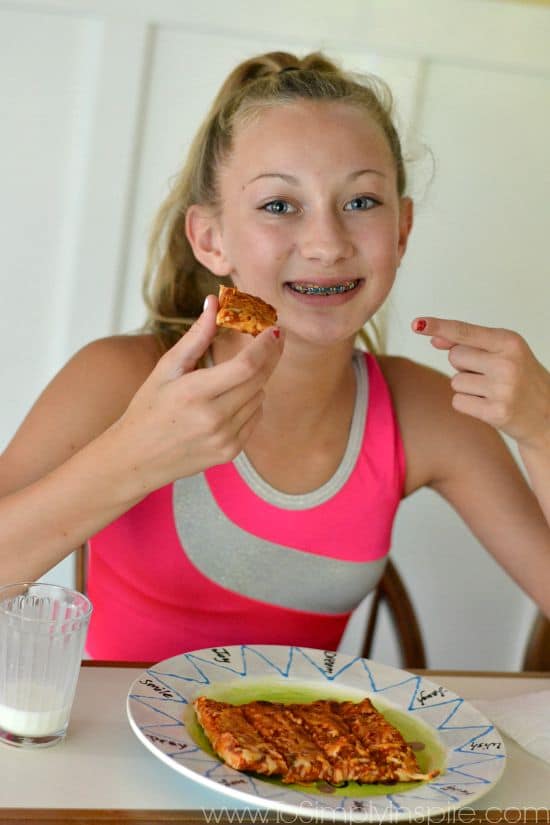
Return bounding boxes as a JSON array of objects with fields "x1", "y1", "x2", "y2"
[{"x1": 127, "y1": 645, "x2": 506, "y2": 822}]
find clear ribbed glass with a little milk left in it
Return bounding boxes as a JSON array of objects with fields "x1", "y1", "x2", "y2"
[{"x1": 0, "y1": 582, "x2": 92, "y2": 747}]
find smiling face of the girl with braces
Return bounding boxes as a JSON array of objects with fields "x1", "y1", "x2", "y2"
[{"x1": 207, "y1": 101, "x2": 412, "y2": 344}]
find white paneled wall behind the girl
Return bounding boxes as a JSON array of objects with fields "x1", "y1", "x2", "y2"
[{"x1": 0, "y1": 0, "x2": 550, "y2": 669}]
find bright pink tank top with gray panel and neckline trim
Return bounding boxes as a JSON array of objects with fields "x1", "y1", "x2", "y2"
[{"x1": 86, "y1": 352, "x2": 405, "y2": 662}]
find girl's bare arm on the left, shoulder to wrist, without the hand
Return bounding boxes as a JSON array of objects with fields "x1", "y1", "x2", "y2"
[{"x1": 0, "y1": 337, "x2": 160, "y2": 582}]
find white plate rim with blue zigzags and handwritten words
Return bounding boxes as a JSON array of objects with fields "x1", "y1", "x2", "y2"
[{"x1": 128, "y1": 645, "x2": 505, "y2": 822}]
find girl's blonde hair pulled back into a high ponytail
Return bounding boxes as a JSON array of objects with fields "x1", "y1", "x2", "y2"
[{"x1": 143, "y1": 52, "x2": 406, "y2": 351}]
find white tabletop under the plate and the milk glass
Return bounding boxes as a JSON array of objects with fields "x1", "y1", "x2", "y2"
[{"x1": 0, "y1": 662, "x2": 550, "y2": 825}]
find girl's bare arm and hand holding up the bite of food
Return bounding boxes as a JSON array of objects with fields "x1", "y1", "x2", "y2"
[{"x1": 0, "y1": 300, "x2": 282, "y2": 583}]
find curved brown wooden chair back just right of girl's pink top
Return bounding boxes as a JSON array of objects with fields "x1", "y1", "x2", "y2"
[{"x1": 361, "y1": 560, "x2": 427, "y2": 669}]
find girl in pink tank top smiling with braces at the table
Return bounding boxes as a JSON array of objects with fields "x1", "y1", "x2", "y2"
[{"x1": 0, "y1": 53, "x2": 550, "y2": 660}]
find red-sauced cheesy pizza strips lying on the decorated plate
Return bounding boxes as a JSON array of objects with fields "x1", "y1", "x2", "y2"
[{"x1": 193, "y1": 696, "x2": 439, "y2": 785}]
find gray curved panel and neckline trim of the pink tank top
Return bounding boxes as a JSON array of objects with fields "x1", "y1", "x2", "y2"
[{"x1": 173, "y1": 355, "x2": 386, "y2": 613}]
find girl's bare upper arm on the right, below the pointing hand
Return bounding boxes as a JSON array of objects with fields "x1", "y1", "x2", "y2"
[{"x1": 383, "y1": 359, "x2": 550, "y2": 616}]
